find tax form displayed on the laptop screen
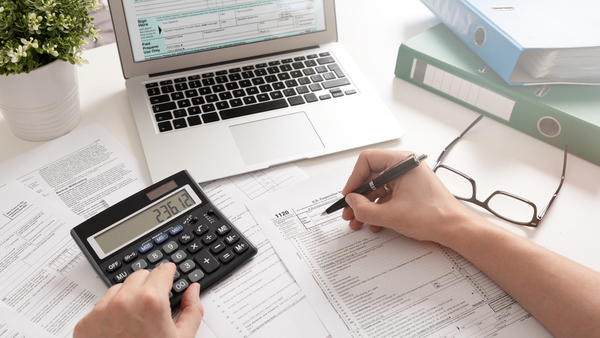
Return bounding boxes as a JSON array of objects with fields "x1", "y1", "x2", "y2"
[{"x1": 123, "y1": 0, "x2": 325, "y2": 62}]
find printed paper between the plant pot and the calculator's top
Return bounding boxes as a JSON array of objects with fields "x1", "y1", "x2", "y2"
[{"x1": 0, "y1": 124, "x2": 151, "y2": 218}]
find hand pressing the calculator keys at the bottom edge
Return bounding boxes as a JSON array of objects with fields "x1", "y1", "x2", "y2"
[{"x1": 73, "y1": 263, "x2": 204, "y2": 338}]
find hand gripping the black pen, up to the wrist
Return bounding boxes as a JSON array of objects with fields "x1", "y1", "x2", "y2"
[{"x1": 342, "y1": 149, "x2": 466, "y2": 243}]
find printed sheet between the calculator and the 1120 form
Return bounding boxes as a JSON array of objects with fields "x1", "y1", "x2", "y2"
[{"x1": 200, "y1": 164, "x2": 329, "y2": 338}]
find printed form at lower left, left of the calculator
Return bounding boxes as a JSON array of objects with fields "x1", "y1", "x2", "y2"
[{"x1": 0, "y1": 181, "x2": 106, "y2": 337}]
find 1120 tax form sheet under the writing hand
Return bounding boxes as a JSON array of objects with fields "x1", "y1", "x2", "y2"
[{"x1": 248, "y1": 168, "x2": 551, "y2": 338}]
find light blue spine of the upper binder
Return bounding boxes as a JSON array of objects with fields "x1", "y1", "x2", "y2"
[{"x1": 421, "y1": 0, "x2": 523, "y2": 84}]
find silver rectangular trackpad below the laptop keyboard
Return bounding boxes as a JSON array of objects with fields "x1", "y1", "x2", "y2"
[{"x1": 229, "y1": 112, "x2": 325, "y2": 165}]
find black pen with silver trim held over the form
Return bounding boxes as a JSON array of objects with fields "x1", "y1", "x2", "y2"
[{"x1": 321, "y1": 154, "x2": 427, "y2": 216}]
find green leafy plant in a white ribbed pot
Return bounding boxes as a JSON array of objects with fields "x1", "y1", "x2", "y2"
[{"x1": 0, "y1": 0, "x2": 101, "y2": 141}]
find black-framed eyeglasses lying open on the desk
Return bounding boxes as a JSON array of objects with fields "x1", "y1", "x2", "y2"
[{"x1": 433, "y1": 115, "x2": 567, "y2": 227}]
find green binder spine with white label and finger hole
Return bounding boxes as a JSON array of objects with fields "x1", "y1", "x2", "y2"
[{"x1": 395, "y1": 45, "x2": 600, "y2": 165}]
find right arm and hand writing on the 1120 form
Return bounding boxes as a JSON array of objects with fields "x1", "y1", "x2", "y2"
[{"x1": 342, "y1": 150, "x2": 600, "y2": 337}]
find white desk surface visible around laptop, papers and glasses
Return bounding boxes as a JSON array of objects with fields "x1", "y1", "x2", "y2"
[{"x1": 0, "y1": 0, "x2": 600, "y2": 278}]
